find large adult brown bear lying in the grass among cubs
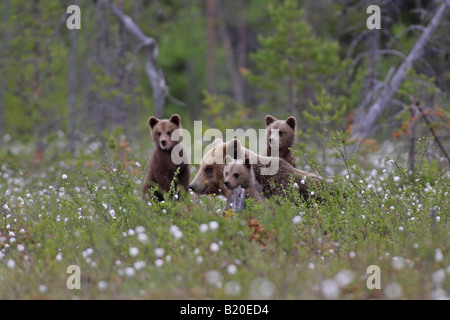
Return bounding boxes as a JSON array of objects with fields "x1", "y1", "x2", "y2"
[{"x1": 189, "y1": 139, "x2": 329, "y2": 199}]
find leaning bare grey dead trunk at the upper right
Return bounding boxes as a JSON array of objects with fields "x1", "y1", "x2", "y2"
[{"x1": 351, "y1": 0, "x2": 450, "y2": 141}]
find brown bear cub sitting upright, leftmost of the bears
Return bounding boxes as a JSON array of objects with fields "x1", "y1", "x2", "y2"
[{"x1": 142, "y1": 114, "x2": 190, "y2": 201}]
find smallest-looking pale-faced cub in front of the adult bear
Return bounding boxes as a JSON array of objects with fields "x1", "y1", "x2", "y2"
[{"x1": 223, "y1": 155, "x2": 263, "y2": 210}]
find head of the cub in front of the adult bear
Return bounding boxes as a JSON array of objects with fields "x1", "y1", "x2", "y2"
[{"x1": 223, "y1": 155, "x2": 254, "y2": 190}]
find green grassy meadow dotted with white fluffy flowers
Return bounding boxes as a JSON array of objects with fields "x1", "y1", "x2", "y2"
[{"x1": 0, "y1": 139, "x2": 450, "y2": 299}]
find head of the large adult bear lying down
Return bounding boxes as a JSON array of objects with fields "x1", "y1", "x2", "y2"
[{"x1": 189, "y1": 138, "x2": 244, "y2": 195}]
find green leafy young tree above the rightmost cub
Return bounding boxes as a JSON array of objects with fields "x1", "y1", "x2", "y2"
[{"x1": 247, "y1": 0, "x2": 343, "y2": 113}]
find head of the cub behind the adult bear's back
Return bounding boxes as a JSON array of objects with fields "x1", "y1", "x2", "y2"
[{"x1": 266, "y1": 115, "x2": 297, "y2": 151}]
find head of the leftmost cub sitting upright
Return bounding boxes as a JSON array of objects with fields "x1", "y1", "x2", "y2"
[{"x1": 148, "y1": 114, "x2": 181, "y2": 151}]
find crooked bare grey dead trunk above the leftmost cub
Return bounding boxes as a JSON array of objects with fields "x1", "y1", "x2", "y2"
[{"x1": 109, "y1": 1, "x2": 169, "y2": 118}]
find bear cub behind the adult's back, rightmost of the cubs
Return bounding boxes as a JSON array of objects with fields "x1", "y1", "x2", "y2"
[{"x1": 265, "y1": 115, "x2": 297, "y2": 167}]
